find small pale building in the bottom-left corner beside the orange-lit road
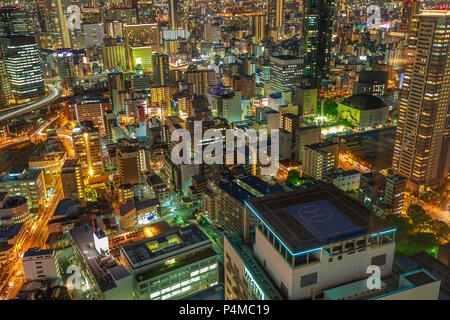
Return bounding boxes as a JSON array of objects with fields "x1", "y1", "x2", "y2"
[{"x1": 23, "y1": 248, "x2": 59, "y2": 281}]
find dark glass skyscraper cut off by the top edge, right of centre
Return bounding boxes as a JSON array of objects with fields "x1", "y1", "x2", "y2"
[{"x1": 302, "y1": 0, "x2": 336, "y2": 86}]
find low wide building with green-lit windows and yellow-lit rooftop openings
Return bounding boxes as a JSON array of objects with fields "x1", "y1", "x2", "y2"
[{"x1": 120, "y1": 225, "x2": 219, "y2": 300}]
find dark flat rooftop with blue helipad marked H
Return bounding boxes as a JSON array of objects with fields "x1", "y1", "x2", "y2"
[{"x1": 246, "y1": 184, "x2": 395, "y2": 254}]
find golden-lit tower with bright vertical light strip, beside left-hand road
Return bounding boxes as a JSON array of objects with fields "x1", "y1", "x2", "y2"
[{"x1": 72, "y1": 121, "x2": 103, "y2": 178}]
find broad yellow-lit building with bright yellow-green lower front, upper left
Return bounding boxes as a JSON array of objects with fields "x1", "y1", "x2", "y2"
[{"x1": 124, "y1": 23, "x2": 159, "y2": 69}]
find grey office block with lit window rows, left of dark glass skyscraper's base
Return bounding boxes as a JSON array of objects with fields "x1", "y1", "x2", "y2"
[{"x1": 270, "y1": 55, "x2": 302, "y2": 92}]
